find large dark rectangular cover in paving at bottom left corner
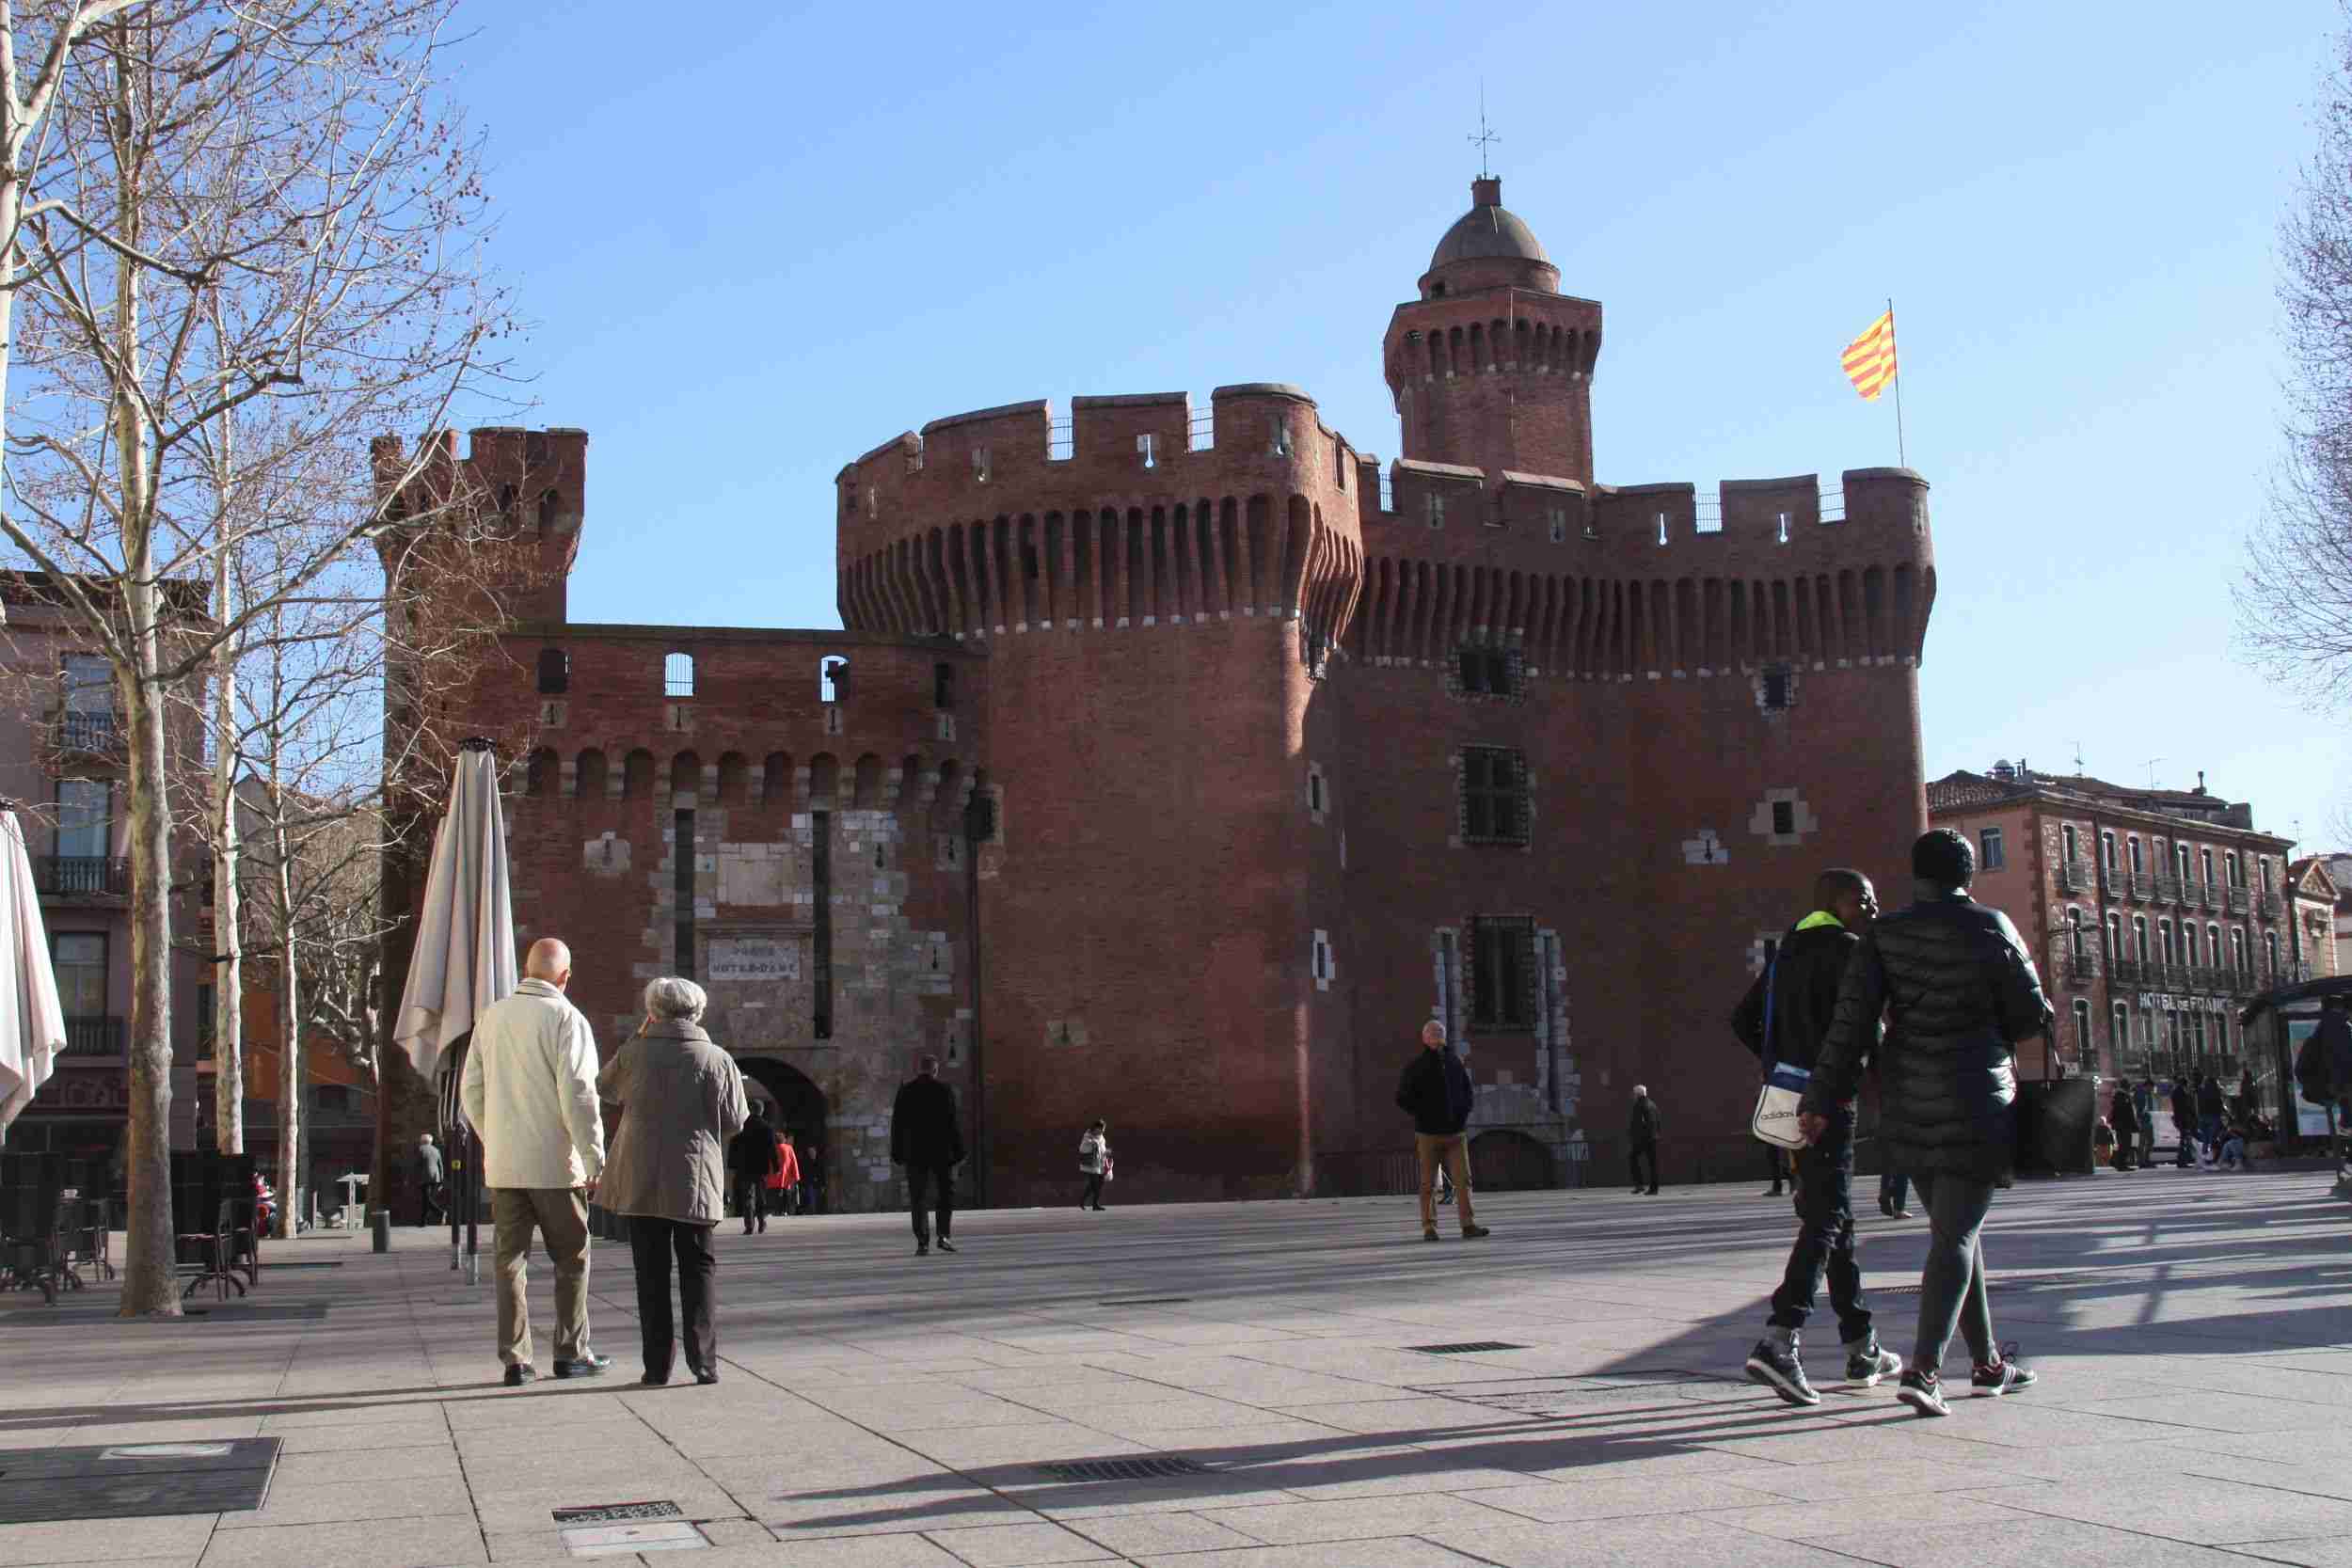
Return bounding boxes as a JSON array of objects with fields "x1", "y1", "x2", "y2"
[{"x1": 0, "y1": 1436, "x2": 280, "y2": 1524}]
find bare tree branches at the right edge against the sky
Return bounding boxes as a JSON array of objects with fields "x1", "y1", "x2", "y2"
[{"x1": 2234, "y1": 10, "x2": 2352, "y2": 712}]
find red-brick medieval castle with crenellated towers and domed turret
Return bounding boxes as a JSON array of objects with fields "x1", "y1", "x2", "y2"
[{"x1": 379, "y1": 179, "x2": 1936, "y2": 1206}]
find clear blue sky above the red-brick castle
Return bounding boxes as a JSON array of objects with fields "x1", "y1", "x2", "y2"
[{"x1": 459, "y1": 0, "x2": 2352, "y2": 842}]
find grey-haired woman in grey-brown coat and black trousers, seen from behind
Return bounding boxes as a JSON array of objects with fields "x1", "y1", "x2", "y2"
[{"x1": 596, "y1": 975, "x2": 751, "y2": 1385}]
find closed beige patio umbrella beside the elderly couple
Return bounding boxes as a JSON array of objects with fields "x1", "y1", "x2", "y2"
[{"x1": 393, "y1": 740, "x2": 517, "y2": 1267}]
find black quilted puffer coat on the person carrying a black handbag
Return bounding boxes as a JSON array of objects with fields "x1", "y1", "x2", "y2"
[{"x1": 1804, "y1": 886, "x2": 2051, "y2": 1182}]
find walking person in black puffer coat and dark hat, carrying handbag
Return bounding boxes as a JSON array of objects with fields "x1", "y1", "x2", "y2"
[{"x1": 1802, "y1": 828, "x2": 2054, "y2": 1416}]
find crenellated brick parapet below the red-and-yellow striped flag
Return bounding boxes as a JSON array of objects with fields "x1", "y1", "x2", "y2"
[{"x1": 1348, "y1": 461, "x2": 1936, "y2": 679}]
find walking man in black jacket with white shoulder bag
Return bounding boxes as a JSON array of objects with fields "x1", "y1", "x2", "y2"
[{"x1": 1731, "y1": 867, "x2": 1903, "y2": 1406}]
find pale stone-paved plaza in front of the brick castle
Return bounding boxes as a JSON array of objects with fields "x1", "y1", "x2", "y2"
[{"x1": 0, "y1": 1168, "x2": 2352, "y2": 1568}]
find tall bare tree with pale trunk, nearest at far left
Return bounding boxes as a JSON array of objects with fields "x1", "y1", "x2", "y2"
[{"x1": 0, "y1": 0, "x2": 511, "y2": 1317}]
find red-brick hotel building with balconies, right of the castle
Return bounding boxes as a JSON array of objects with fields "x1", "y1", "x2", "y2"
[{"x1": 1927, "y1": 762, "x2": 2336, "y2": 1079}]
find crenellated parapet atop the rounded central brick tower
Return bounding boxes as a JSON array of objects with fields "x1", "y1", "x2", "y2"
[{"x1": 835, "y1": 383, "x2": 1362, "y2": 667}]
